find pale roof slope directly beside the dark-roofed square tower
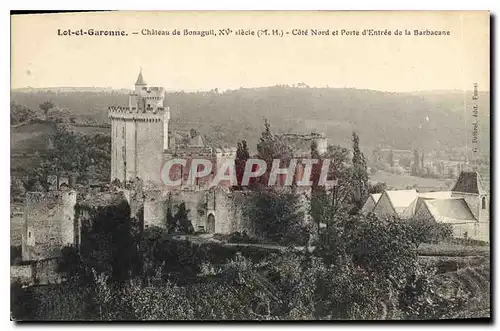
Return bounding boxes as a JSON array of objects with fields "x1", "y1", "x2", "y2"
[{"x1": 424, "y1": 198, "x2": 476, "y2": 223}]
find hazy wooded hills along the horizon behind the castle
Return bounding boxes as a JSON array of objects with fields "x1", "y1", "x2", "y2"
[{"x1": 11, "y1": 86, "x2": 490, "y2": 151}]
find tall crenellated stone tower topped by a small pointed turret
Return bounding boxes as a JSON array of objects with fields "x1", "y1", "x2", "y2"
[{"x1": 109, "y1": 70, "x2": 170, "y2": 183}]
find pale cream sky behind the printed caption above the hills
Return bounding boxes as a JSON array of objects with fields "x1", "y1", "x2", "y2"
[{"x1": 11, "y1": 11, "x2": 490, "y2": 92}]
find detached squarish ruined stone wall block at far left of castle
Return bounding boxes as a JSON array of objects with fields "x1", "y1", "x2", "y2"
[{"x1": 22, "y1": 191, "x2": 76, "y2": 260}]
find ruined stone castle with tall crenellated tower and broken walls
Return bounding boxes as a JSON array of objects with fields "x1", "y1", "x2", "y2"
[{"x1": 17, "y1": 71, "x2": 318, "y2": 274}]
